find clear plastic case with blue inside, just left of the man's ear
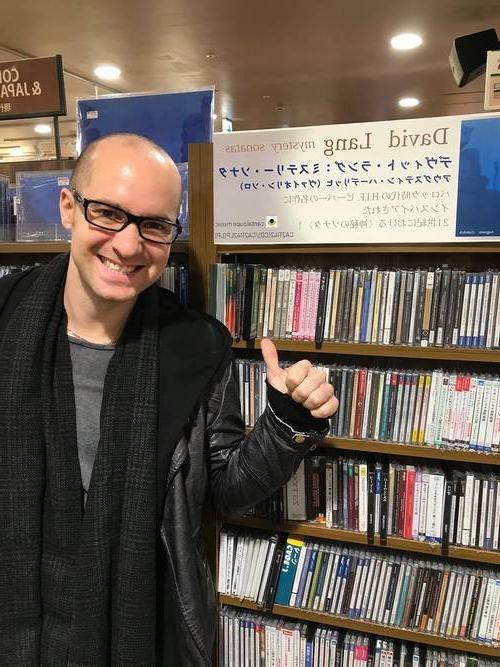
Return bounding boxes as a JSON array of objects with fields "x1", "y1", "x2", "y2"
[{"x1": 16, "y1": 170, "x2": 71, "y2": 241}]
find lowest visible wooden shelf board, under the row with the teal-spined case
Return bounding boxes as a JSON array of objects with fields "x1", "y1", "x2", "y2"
[{"x1": 219, "y1": 595, "x2": 500, "y2": 657}]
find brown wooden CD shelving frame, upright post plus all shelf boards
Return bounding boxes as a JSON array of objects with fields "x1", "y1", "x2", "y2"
[{"x1": 189, "y1": 145, "x2": 500, "y2": 664}]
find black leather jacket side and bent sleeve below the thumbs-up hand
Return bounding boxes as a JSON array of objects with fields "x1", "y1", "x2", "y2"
[{"x1": 161, "y1": 351, "x2": 324, "y2": 667}]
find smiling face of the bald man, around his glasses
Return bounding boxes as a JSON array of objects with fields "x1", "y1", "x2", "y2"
[{"x1": 60, "y1": 141, "x2": 180, "y2": 302}]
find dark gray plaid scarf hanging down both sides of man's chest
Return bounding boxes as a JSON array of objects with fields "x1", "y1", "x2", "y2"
[{"x1": 0, "y1": 256, "x2": 158, "y2": 667}]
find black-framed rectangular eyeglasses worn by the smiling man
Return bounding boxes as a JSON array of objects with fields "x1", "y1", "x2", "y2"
[{"x1": 71, "y1": 188, "x2": 182, "y2": 245}]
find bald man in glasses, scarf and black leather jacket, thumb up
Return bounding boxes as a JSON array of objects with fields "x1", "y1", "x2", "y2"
[{"x1": 0, "y1": 134, "x2": 337, "y2": 667}]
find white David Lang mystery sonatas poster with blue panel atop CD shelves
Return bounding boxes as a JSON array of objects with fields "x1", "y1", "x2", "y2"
[{"x1": 214, "y1": 114, "x2": 500, "y2": 245}]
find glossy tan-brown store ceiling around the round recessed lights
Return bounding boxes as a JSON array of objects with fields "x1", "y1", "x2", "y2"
[{"x1": 0, "y1": 0, "x2": 500, "y2": 160}]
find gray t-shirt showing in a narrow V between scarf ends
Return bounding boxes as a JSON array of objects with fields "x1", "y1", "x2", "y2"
[{"x1": 68, "y1": 336, "x2": 115, "y2": 504}]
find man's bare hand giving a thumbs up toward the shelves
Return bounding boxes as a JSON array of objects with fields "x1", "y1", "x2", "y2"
[{"x1": 260, "y1": 338, "x2": 339, "y2": 419}]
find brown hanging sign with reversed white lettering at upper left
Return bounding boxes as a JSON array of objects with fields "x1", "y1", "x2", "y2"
[{"x1": 0, "y1": 56, "x2": 66, "y2": 120}]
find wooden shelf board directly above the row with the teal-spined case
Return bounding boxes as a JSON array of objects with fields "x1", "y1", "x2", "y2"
[{"x1": 223, "y1": 517, "x2": 500, "y2": 565}]
